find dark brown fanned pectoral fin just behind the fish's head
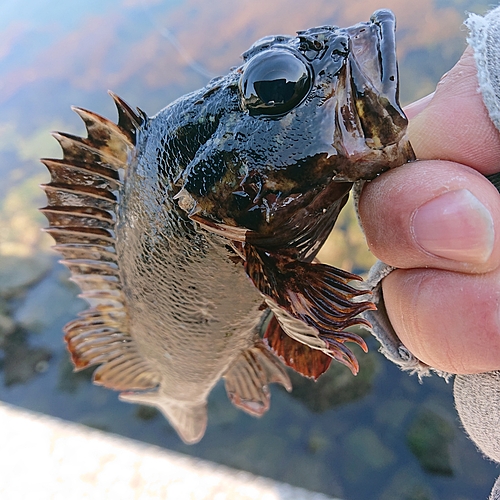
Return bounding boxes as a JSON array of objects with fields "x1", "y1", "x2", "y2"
[{"x1": 244, "y1": 244, "x2": 375, "y2": 374}]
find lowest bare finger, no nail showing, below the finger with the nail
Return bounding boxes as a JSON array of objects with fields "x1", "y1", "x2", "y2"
[{"x1": 382, "y1": 269, "x2": 500, "y2": 373}]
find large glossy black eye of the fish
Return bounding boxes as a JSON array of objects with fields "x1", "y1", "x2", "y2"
[{"x1": 240, "y1": 49, "x2": 312, "y2": 115}]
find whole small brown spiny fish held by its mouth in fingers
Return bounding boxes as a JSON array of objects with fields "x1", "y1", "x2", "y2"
[{"x1": 41, "y1": 10, "x2": 415, "y2": 444}]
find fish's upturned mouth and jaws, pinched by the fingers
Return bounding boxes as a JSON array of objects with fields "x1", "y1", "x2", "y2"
[{"x1": 328, "y1": 9, "x2": 415, "y2": 182}]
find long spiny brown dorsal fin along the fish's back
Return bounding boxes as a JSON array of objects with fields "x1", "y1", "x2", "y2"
[{"x1": 41, "y1": 94, "x2": 159, "y2": 390}]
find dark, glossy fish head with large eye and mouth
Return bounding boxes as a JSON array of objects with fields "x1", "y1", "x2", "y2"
[{"x1": 177, "y1": 10, "x2": 414, "y2": 252}]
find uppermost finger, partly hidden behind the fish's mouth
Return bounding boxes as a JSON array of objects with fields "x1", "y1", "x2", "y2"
[{"x1": 408, "y1": 48, "x2": 500, "y2": 174}]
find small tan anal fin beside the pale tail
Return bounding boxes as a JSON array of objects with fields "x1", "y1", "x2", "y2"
[{"x1": 223, "y1": 339, "x2": 292, "y2": 417}]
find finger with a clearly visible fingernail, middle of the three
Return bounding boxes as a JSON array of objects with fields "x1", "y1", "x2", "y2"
[{"x1": 359, "y1": 160, "x2": 500, "y2": 273}]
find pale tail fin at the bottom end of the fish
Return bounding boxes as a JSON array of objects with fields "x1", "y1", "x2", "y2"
[{"x1": 119, "y1": 390, "x2": 207, "y2": 444}]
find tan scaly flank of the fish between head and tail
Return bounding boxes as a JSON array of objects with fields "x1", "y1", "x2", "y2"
[{"x1": 116, "y1": 150, "x2": 263, "y2": 400}]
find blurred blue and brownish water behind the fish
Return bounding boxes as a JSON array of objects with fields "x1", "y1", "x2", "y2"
[{"x1": 0, "y1": 0, "x2": 498, "y2": 500}]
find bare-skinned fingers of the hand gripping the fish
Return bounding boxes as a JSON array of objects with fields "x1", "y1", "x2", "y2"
[{"x1": 359, "y1": 49, "x2": 500, "y2": 373}]
